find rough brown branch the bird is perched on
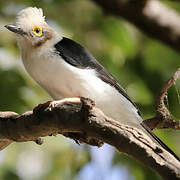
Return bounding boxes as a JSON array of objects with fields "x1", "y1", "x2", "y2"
[{"x1": 0, "y1": 98, "x2": 180, "y2": 179}]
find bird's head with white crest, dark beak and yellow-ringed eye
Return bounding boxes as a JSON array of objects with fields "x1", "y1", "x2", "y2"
[{"x1": 5, "y1": 7, "x2": 55, "y2": 47}]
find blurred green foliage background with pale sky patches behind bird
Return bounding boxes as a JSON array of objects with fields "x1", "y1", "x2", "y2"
[{"x1": 0, "y1": 0, "x2": 180, "y2": 180}]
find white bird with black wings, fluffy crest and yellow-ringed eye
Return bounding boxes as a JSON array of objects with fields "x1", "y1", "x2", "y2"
[{"x1": 5, "y1": 7, "x2": 179, "y2": 160}]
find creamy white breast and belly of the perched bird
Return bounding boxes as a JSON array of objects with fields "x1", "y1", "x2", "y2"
[{"x1": 23, "y1": 50, "x2": 141, "y2": 126}]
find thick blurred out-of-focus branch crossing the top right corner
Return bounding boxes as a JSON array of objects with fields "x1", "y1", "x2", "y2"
[{"x1": 93, "y1": 0, "x2": 180, "y2": 52}]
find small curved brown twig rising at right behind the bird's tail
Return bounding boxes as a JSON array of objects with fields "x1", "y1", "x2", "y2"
[{"x1": 144, "y1": 68, "x2": 180, "y2": 130}]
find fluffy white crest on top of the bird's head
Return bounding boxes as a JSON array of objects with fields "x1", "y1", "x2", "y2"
[{"x1": 16, "y1": 7, "x2": 45, "y2": 31}]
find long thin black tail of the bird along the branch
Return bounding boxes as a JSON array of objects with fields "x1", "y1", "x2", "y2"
[{"x1": 141, "y1": 122, "x2": 180, "y2": 161}]
